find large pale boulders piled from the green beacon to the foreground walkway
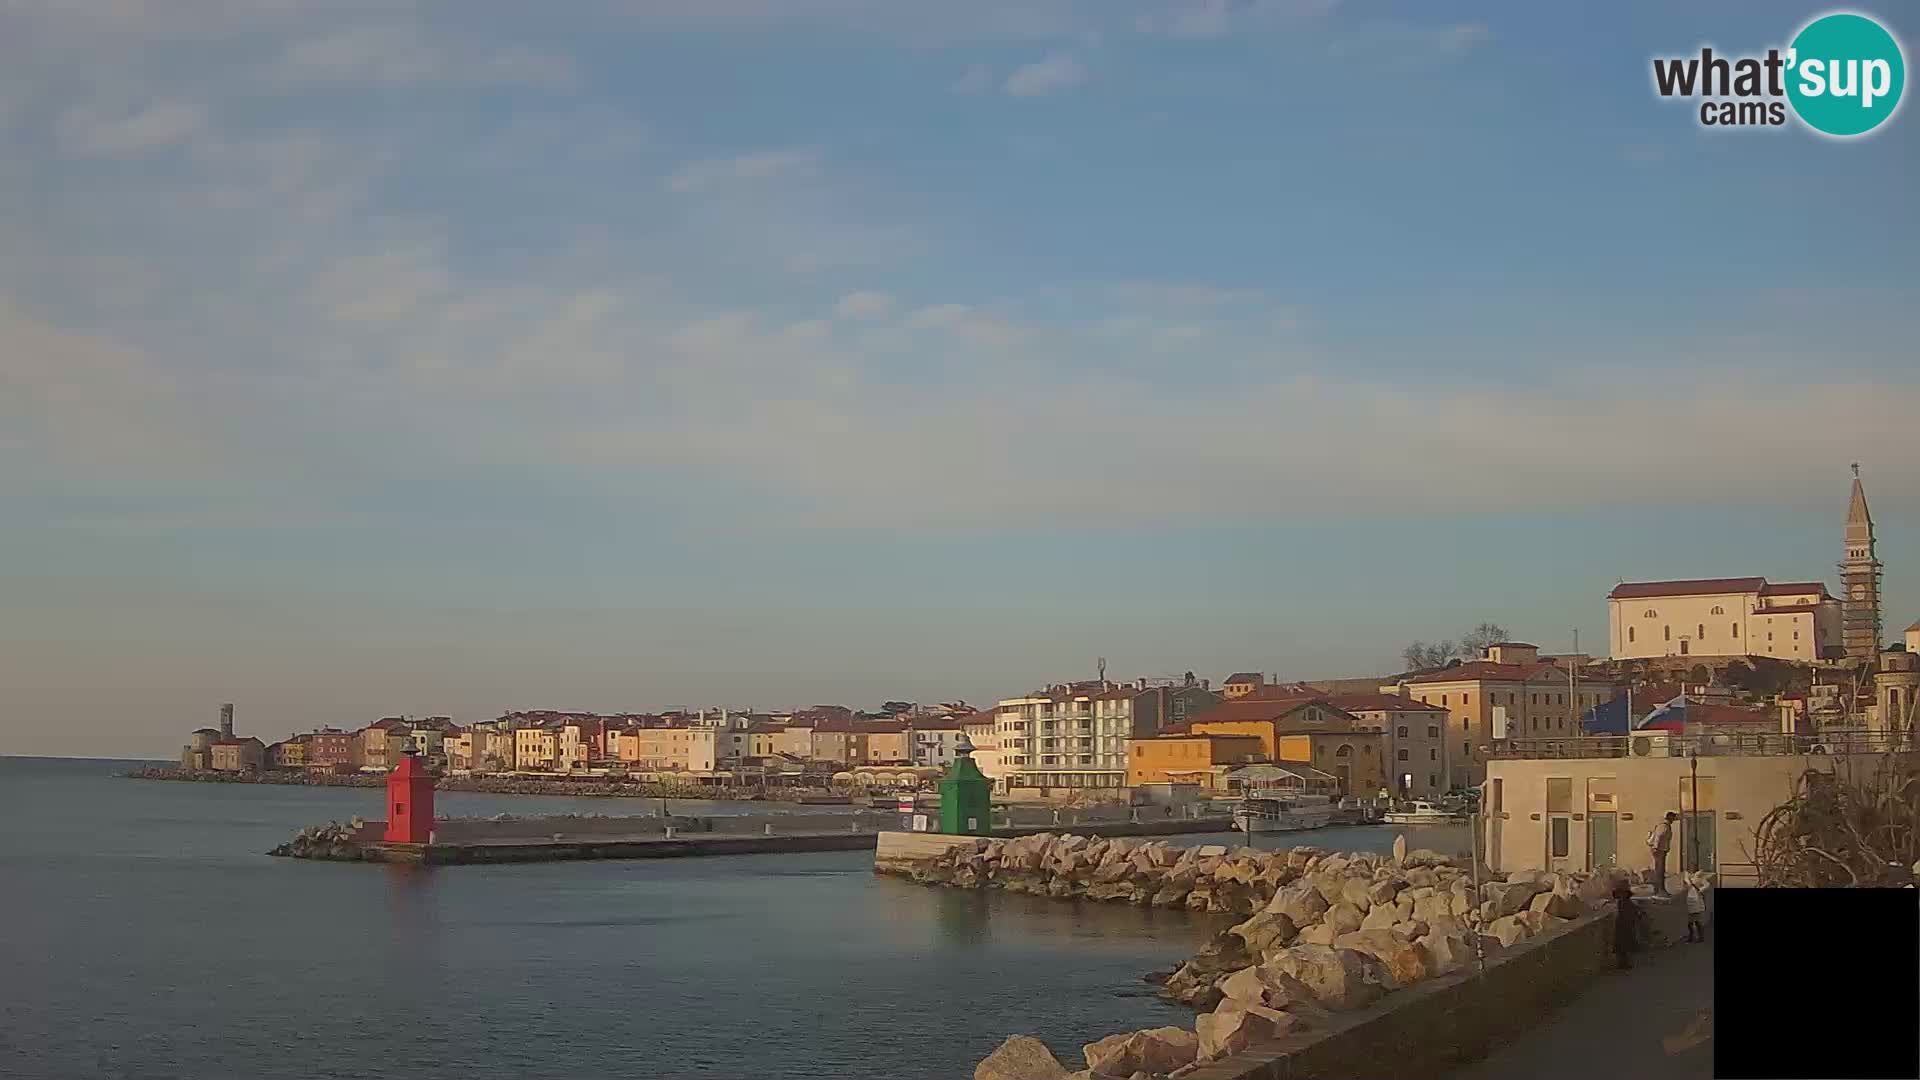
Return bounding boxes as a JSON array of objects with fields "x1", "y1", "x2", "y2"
[{"x1": 890, "y1": 834, "x2": 1611, "y2": 1080}]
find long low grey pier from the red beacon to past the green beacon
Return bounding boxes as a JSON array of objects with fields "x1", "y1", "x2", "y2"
[{"x1": 269, "y1": 811, "x2": 1233, "y2": 867}]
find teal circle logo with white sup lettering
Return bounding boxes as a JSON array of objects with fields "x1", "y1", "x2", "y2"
[{"x1": 1788, "y1": 13, "x2": 1907, "y2": 138}]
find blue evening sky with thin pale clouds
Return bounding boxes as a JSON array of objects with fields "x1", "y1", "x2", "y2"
[{"x1": 0, "y1": 0, "x2": 1920, "y2": 755}]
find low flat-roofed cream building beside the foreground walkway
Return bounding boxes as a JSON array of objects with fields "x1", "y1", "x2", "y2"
[{"x1": 1480, "y1": 730, "x2": 1916, "y2": 886}]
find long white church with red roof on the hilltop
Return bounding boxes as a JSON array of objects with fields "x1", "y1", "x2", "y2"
[{"x1": 1607, "y1": 577, "x2": 1843, "y2": 663}]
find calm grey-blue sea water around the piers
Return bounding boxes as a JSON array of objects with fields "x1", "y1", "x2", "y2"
[{"x1": 0, "y1": 757, "x2": 1466, "y2": 1080}]
